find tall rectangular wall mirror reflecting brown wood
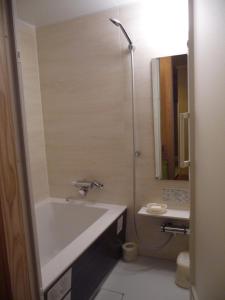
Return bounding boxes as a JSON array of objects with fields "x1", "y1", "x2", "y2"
[{"x1": 151, "y1": 54, "x2": 189, "y2": 180}]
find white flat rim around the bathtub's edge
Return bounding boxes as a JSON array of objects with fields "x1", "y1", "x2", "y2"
[{"x1": 35, "y1": 197, "x2": 127, "y2": 292}]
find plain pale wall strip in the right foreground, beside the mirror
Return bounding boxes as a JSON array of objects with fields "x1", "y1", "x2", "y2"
[{"x1": 192, "y1": 0, "x2": 225, "y2": 300}]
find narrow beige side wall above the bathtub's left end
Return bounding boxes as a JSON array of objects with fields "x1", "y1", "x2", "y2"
[{"x1": 17, "y1": 21, "x2": 49, "y2": 201}]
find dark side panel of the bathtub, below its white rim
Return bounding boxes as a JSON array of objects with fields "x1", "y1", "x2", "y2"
[{"x1": 45, "y1": 212, "x2": 126, "y2": 300}]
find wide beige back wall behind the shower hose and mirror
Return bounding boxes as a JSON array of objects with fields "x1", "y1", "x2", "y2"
[{"x1": 37, "y1": 1, "x2": 189, "y2": 258}]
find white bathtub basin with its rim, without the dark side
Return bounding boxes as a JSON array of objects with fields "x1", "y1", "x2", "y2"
[{"x1": 35, "y1": 198, "x2": 126, "y2": 290}]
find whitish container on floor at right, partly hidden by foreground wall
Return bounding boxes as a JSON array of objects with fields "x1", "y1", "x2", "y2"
[{"x1": 176, "y1": 252, "x2": 190, "y2": 289}]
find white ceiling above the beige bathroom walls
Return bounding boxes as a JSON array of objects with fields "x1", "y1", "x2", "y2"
[{"x1": 16, "y1": 0, "x2": 137, "y2": 26}]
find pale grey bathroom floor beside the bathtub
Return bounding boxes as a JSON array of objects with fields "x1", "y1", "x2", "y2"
[{"x1": 95, "y1": 257, "x2": 189, "y2": 300}]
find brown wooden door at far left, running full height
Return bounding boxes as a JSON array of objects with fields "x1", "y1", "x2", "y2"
[{"x1": 0, "y1": 0, "x2": 37, "y2": 300}]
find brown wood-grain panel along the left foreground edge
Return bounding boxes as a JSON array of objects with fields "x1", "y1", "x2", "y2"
[{"x1": 0, "y1": 0, "x2": 37, "y2": 300}]
